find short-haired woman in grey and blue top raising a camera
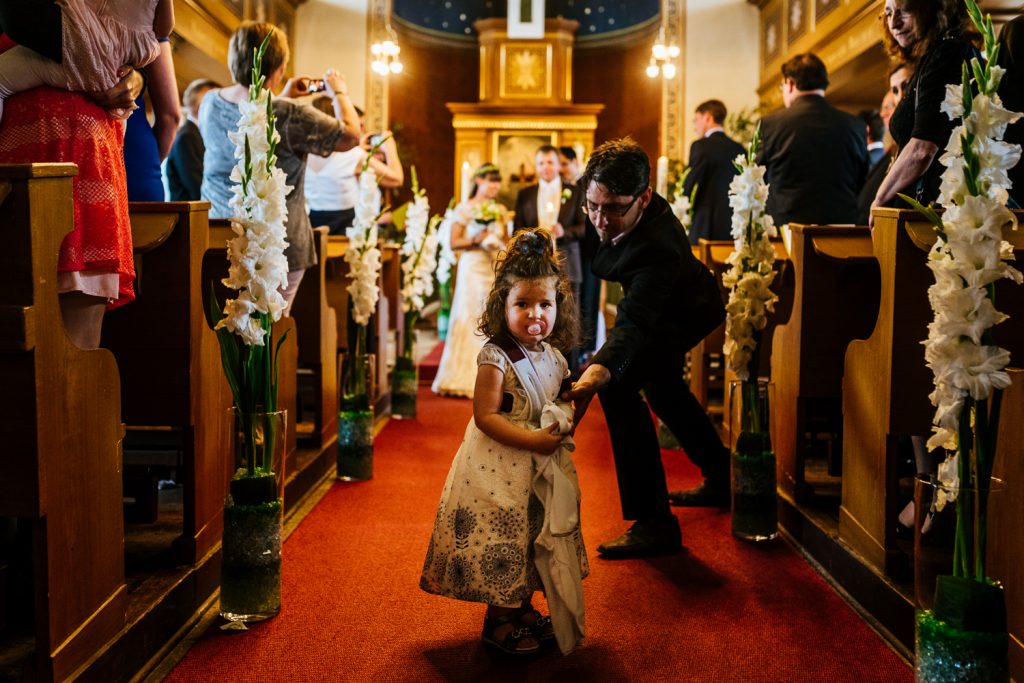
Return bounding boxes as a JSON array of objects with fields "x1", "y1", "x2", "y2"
[{"x1": 199, "y1": 22, "x2": 359, "y2": 314}]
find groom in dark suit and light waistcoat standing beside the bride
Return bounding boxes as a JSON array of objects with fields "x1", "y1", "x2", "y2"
[{"x1": 514, "y1": 144, "x2": 584, "y2": 374}]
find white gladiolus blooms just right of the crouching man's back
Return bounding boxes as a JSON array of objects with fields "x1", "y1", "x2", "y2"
[{"x1": 722, "y1": 145, "x2": 778, "y2": 380}]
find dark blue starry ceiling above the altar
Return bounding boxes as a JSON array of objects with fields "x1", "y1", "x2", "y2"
[{"x1": 391, "y1": 0, "x2": 662, "y2": 42}]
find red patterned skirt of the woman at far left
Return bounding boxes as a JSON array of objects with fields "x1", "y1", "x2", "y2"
[{"x1": 0, "y1": 88, "x2": 135, "y2": 308}]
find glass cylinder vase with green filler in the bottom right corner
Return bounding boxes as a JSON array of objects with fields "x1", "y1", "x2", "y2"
[{"x1": 913, "y1": 475, "x2": 1010, "y2": 683}]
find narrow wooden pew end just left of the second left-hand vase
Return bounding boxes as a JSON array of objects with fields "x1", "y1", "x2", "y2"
[{"x1": 292, "y1": 227, "x2": 338, "y2": 447}]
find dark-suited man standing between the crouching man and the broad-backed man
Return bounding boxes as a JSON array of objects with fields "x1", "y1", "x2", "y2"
[{"x1": 683, "y1": 99, "x2": 743, "y2": 245}]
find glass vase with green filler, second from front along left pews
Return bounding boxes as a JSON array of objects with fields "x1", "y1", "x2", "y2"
[{"x1": 338, "y1": 353, "x2": 375, "y2": 481}]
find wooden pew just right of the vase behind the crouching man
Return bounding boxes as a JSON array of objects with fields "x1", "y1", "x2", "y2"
[{"x1": 771, "y1": 223, "x2": 879, "y2": 501}]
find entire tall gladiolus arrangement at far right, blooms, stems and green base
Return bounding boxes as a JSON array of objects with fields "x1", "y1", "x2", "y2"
[{"x1": 904, "y1": 0, "x2": 1022, "y2": 680}]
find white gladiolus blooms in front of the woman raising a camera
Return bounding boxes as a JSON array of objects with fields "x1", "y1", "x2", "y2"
[{"x1": 217, "y1": 83, "x2": 291, "y2": 346}]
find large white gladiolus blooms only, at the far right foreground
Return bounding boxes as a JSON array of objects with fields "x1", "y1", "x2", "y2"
[{"x1": 924, "y1": 45, "x2": 1022, "y2": 456}]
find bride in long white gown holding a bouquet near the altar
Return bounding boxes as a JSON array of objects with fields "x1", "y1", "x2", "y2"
[{"x1": 431, "y1": 163, "x2": 508, "y2": 398}]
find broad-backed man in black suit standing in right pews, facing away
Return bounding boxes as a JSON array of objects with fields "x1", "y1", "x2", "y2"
[{"x1": 757, "y1": 52, "x2": 867, "y2": 225}]
